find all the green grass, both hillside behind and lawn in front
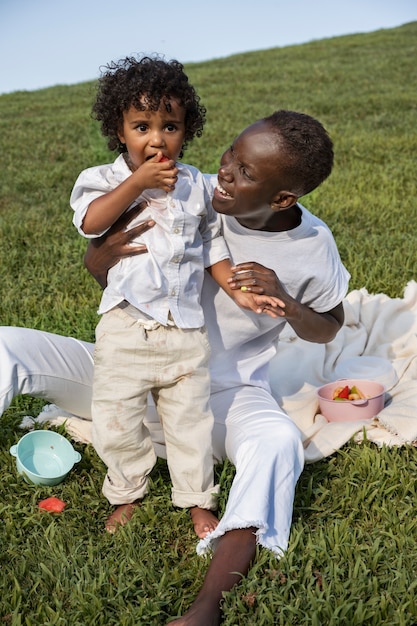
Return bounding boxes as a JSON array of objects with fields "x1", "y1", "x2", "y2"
[{"x1": 0, "y1": 23, "x2": 417, "y2": 626}]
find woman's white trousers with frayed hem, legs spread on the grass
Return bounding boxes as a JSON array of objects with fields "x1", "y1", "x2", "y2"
[{"x1": 0, "y1": 327, "x2": 304, "y2": 555}]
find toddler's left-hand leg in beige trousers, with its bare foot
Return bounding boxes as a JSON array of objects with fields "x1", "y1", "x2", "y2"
[{"x1": 92, "y1": 309, "x2": 156, "y2": 525}]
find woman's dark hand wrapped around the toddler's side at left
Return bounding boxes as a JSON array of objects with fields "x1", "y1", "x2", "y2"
[{"x1": 84, "y1": 202, "x2": 155, "y2": 289}]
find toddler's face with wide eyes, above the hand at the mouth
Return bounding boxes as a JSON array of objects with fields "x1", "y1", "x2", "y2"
[{"x1": 119, "y1": 100, "x2": 185, "y2": 170}]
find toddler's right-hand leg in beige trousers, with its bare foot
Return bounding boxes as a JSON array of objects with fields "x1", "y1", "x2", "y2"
[{"x1": 154, "y1": 328, "x2": 218, "y2": 537}]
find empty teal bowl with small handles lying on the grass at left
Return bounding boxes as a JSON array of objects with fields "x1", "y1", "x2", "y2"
[{"x1": 10, "y1": 430, "x2": 81, "y2": 485}]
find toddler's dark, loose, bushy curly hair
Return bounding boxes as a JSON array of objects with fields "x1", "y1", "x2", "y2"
[{"x1": 92, "y1": 55, "x2": 206, "y2": 158}]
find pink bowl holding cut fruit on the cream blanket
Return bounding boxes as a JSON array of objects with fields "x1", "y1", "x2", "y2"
[{"x1": 317, "y1": 378, "x2": 385, "y2": 422}]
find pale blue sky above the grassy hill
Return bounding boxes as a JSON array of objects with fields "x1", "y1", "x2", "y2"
[{"x1": 0, "y1": 0, "x2": 417, "y2": 93}]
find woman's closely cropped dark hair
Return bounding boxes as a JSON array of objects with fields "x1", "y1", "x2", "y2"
[{"x1": 263, "y1": 110, "x2": 334, "y2": 197}]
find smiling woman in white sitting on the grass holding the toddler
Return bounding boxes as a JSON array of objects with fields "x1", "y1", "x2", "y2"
[{"x1": 0, "y1": 111, "x2": 349, "y2": 626}]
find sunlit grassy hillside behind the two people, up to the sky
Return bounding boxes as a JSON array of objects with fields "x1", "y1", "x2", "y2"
[{"x1": 0, "y1": 22, "x2": 417, "y2": 339}]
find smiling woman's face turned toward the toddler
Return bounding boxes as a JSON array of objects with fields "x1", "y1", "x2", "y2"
[{"x1": 213, "y1": 120, "x2": 285, "y2": 229}]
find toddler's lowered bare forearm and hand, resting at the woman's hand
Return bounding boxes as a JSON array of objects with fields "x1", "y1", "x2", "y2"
[{"x1": 207, "y1": 259, "x2": 283, "y2": 317}]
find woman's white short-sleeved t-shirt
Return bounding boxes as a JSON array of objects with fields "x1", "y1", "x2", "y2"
[{"x1": 202, "y1": 176, "x2": 350, "y2": 392}]
